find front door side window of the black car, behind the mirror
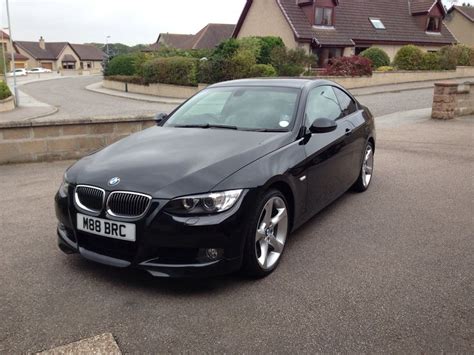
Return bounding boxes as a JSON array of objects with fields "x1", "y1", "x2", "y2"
[{"x1": 305, "y1": 86, "x2": 343, "y2": 127}]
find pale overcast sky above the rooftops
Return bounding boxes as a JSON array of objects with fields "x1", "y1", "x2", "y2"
[{"x1": 0, "y1": 0, "x2": 474, "y2": 45}]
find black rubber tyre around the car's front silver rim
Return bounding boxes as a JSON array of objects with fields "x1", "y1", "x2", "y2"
[{"x1": 242, "y1": 189, "x2": 290, "y2": 278}]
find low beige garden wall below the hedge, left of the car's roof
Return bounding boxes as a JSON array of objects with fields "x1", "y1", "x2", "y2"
[{"x1": 102, "y1": 80, "x2": 207, "y2": 99}]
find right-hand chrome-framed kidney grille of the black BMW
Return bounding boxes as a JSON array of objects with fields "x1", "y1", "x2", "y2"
[{"x1": 107, "y1": 191, "x2": 151, "y2": 218}]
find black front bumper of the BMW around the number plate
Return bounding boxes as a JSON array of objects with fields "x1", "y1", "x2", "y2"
[{"x1": 55, "y1": 187, "x2": 256, "y2": 277}]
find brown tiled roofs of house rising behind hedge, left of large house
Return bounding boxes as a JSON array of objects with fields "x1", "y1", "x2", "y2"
[{"x1": 146, "y1": 23, "x2": 235, "y2": 51}]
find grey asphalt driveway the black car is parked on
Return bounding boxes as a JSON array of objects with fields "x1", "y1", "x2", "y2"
[{"x1": 0, "y1": 118, "x2": 474, "y2": 353}]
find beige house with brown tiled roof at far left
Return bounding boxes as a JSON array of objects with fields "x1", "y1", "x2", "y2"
[{"x1": 14, "y1": 37, "x2": 104, "y2": 73}]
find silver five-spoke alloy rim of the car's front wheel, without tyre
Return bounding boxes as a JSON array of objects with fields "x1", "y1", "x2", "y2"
[{"x1": 255, "y1": 196, "x2": 288, "y2": 270}]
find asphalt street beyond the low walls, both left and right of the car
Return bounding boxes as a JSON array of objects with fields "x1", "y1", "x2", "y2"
[{"x1": 21, "y1": 76, "x2": 440, "y2": 119}]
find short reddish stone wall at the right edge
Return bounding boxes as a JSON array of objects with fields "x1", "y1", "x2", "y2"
[{"x1": 431, "y1": 82, "x2": 474, "y2": 120}]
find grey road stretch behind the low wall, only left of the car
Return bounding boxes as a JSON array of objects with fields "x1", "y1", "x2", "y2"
[{"x1": 20, "y1": 76, "x2": 178, "y2": 119}]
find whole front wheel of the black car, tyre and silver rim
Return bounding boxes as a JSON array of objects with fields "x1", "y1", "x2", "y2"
[{"x1": 244, "y1": 190, "x2": 289, "y2": 277}]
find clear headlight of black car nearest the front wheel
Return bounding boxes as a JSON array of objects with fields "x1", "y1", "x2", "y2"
[{"x1": 166, "y1": 190, "x2": 243, "y2": 214}]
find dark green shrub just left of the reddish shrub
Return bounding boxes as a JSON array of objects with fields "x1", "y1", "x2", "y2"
[{"x1": 271, "y1": 47, "x2": 316, "y2": 76}]
